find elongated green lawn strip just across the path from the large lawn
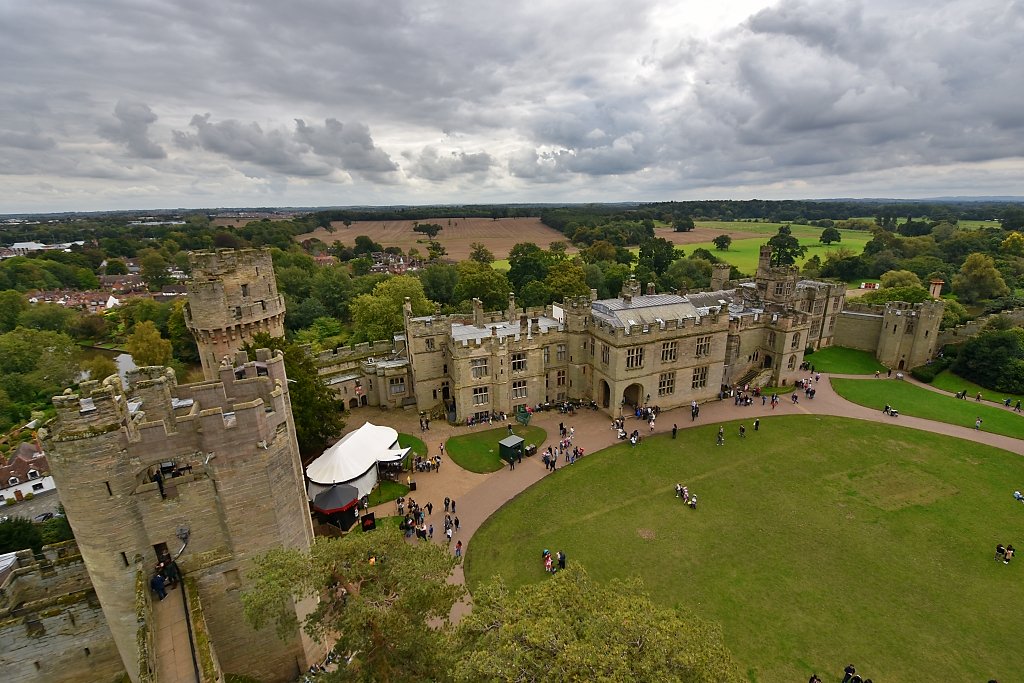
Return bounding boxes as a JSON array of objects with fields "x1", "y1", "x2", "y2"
[{"x1": 831, "y1": 376, "x2": 1024, "y2": 440}]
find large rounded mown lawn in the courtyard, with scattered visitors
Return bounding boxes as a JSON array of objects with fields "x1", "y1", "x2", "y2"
[{"x1": 465, "y1": 417, "x2": 1024, "y2": 681}]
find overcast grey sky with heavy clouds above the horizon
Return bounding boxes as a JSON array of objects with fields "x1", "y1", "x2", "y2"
[{"x1": 0, "y1": 0, "x2": 1024, "y2": 213}]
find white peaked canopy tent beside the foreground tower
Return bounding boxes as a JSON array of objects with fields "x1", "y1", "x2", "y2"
[{"x1": 306, "y1": 422, "x2": 410, "y2": 501}]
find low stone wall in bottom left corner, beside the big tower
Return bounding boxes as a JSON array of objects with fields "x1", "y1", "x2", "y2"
[{"x1": 0, "y1": 541, "x2": 125, "y2": 683}]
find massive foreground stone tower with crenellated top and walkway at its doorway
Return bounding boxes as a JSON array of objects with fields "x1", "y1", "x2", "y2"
[{"x1": 44, "y1": 349, "x2": 322, "y2": 681}]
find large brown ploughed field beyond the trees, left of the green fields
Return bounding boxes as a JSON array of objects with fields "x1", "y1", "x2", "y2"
[{"x1": 295, "y1": 217, "x2": 577, "y2": 261}]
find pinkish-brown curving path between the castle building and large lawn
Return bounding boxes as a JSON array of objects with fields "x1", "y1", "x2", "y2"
[{"x1": 348, "y1": 373, "x2": 1024, "y2": 622}]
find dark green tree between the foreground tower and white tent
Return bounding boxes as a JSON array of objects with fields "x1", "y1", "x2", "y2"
[{"x1": 243, "y1": 332, "x2": 345, "y2": 460}]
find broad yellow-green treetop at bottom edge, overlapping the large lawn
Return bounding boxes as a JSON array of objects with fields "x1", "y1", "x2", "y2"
[{"x1": 453, "y1": 567, "x2": 744, "y2": 683}]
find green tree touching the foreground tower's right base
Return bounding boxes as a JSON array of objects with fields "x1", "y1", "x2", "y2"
[{"x1": 242, "y1": 526, "x2": 458, "y2": 682}]
